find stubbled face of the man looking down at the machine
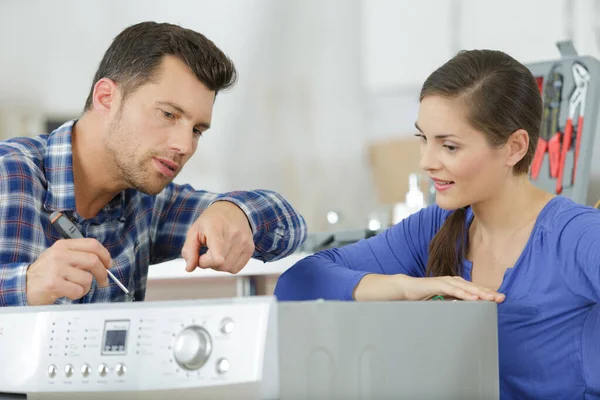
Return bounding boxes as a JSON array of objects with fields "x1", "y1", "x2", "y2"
[{"x1": 105, "y1": 56, "x2": 215, "y2": 195}]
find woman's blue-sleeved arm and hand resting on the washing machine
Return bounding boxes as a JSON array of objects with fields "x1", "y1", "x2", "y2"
[{"x1": 275, "y1": 206, "x2": 504, "y2": 302}]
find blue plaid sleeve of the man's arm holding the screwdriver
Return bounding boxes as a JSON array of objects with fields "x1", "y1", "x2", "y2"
[{"x1": 0, "y1": 157, "x2": 43, "y2": 307}]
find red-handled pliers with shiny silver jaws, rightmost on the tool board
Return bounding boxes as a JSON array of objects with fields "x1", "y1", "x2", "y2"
[{"x1": 556, "y1": 62, "x2": 590, "y2": 194}]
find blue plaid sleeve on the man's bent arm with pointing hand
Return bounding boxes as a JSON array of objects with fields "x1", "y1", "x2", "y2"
[{"x1": 151, "y1": 184, "x2": 306, "y2": 264}]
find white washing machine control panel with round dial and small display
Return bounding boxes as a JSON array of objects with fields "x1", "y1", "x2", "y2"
[{"x1": 0, "y1": 298, "x2": 275, "y2": 392}]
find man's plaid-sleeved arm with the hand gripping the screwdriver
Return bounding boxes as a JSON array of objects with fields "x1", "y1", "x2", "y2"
[{"x1": 0, "y1": 153, "x2": 118, "y2": 307}]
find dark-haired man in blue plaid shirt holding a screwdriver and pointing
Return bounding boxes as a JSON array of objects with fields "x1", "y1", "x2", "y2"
[{"x1": 0, "y1": 22, "x2": 306, "y2": 306}]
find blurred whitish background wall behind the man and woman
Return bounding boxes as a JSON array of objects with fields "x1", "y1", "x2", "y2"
[{"x1": 0, "y1": 0, "x2": 600, "y2": 231}]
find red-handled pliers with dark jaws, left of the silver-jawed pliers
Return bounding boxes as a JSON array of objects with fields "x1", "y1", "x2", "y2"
[{"x1": 531, "y1": 66, "x2": 563, "y2": 179}]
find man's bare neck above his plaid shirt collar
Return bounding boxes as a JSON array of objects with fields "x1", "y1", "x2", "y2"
[{"x1": 71, "y1": 113, "x2": 126, "y2": 218}]
